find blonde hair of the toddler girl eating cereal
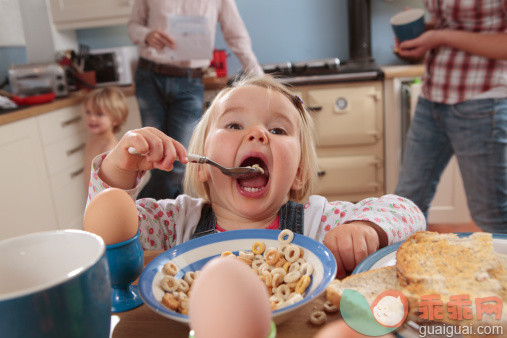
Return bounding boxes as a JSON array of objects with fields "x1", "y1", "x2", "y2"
[{"x1": 184, "y1": 75, "x2": 318, "y2": 202}]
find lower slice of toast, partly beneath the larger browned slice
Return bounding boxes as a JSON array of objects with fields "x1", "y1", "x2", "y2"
[{"x1": 326, "y1": 266, "x2": 401, "y2": 309}]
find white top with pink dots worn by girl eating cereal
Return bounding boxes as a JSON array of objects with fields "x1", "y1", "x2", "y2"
[{"x1": 88, "y1": 153, "x2": 426, "y2": 250}]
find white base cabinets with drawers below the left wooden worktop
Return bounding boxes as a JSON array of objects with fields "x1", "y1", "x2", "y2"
[{"x1": 0, "y1": 96, "x2": 141, "y2": 239}]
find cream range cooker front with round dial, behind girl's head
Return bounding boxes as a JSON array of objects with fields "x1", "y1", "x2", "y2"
[{"x1": 293, "y1": 81, "x2": 384, "y2": 202}]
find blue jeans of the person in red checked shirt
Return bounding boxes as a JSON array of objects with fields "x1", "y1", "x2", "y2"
[{"x1": 395, "y1": 98, "x2": 507, "y2": 233}]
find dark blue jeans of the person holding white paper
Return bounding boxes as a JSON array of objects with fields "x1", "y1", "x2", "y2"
[{"x1": 135, "y1": 67, "x2": 204, "y2": 199}]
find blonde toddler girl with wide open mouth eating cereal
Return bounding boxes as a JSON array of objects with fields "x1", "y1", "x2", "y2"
[{"x1": 89, "y1": 76, "x2": 426, "y2": 277}]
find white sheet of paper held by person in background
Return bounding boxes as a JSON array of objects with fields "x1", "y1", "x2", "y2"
[{"x1": 164, "y1": 14, "x2": 213, "y2": 61}]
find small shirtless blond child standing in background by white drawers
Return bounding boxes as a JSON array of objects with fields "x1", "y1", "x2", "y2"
[{"x1": 84, "y1": 87, "x2": 128, "y2": 187}]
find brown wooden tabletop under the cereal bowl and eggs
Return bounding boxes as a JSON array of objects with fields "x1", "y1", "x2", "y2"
[{"x1": 112, "y1": 251, "x2": 340, "y2": 338}]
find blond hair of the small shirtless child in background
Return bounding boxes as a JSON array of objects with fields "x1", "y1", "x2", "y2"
[{"x1": 84, "y1": 87, "x2": 129, "y2": 133}]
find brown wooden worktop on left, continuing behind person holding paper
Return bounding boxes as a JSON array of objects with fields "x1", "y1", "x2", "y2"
[{"x1": 0, "y1": 78, "x2": 228, "y2": 126}]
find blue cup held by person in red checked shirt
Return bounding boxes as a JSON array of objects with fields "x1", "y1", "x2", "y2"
[{"x1": 391, "y1": 8, "x2": 426, "y2": 43}]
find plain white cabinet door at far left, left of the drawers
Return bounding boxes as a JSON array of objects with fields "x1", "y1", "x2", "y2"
[{"x1": 0, "y1": 118, "x2": 57, "y2": 240}]
